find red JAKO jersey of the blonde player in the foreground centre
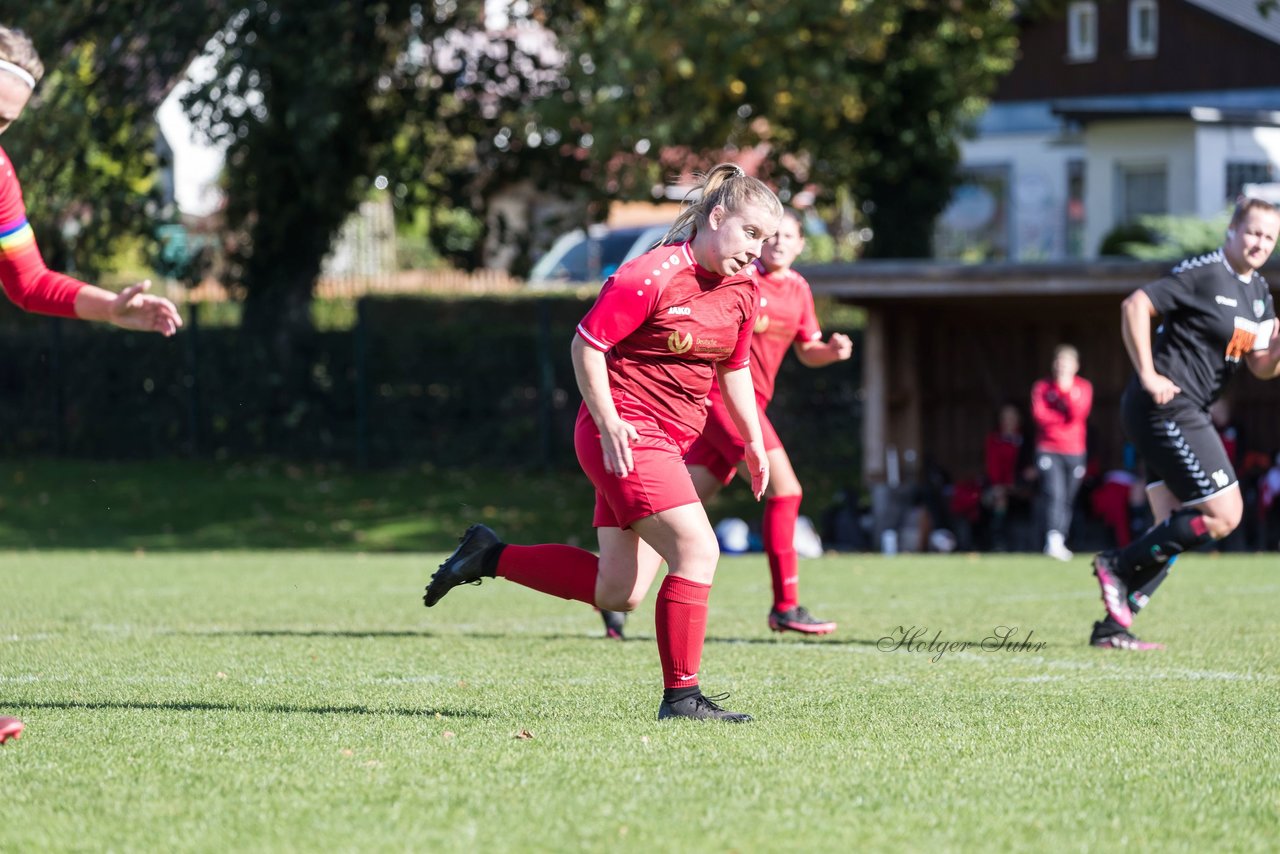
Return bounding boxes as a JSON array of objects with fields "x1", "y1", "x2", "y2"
[{"x1": 577, "y1": 243, "x2": 758, "y2": 453}]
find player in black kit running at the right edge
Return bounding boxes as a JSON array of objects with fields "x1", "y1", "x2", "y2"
[{"x1": 1091, "y1": 198, "x2": 1280, "y2": 649}]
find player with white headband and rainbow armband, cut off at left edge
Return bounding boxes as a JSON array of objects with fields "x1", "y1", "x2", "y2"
[{"x1": 0, "y1": 24, "x2": 182, "y2": 744}]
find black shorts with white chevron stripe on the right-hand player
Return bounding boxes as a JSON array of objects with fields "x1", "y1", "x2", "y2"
[{"x1": 1120, "y1": 383, "x2": 1235, "y2": 504}]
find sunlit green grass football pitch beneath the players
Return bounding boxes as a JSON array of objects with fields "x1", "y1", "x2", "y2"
[{"x1": 0, "y1": 551, "x2": 1280, "y2": 851}]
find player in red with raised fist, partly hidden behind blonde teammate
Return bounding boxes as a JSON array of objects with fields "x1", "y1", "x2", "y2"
[{"x1": 604, "y1": 210, "x2": 854, "y2": 635}]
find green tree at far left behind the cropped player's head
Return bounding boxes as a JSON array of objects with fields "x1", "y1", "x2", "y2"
[{"x1": 4, "y1": 0, "x2": 225, "y2": 277}]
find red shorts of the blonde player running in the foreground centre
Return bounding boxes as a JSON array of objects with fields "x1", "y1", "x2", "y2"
[{"x1": 573, "y1": 405, "x2": 698, "y2": 529}]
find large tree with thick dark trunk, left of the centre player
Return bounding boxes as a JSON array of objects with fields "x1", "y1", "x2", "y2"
[{"x1": 186, "y1": 0, "x2": 576, "y2": 338}]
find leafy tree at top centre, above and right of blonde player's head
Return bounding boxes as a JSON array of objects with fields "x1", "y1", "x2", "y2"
[{"x1": 541, "y1": 0, "x2": 1061, "y2": 257}]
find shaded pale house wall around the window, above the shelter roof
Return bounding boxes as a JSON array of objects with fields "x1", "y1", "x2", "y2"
[{"x1": 1084, "y1": 119, "x2": 1192, "y2": 257}]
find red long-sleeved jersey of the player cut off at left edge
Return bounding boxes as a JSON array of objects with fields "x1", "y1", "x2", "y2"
[{"x1": 0, "y1": 149, "x2": 84, "y2": 318}]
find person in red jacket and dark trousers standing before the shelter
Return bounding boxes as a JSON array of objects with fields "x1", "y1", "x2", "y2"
[{"x1": 1032, "y1": 344, "x2": 1093, "y2": 561}]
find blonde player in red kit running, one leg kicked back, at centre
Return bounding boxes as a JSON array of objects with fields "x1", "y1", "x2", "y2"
[{"x1": 424, "y1": 164, "x2": 782, "y2": 721}]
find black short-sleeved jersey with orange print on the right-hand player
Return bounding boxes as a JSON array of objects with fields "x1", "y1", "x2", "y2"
[{"x1": 1142, "y1": 248, "x2": 1276, "y2": 407}]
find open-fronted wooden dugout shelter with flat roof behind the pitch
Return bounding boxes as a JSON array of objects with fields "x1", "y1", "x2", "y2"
[{"x1": 800, "y1": 260, "x2": 1280, "y2": 484}]
